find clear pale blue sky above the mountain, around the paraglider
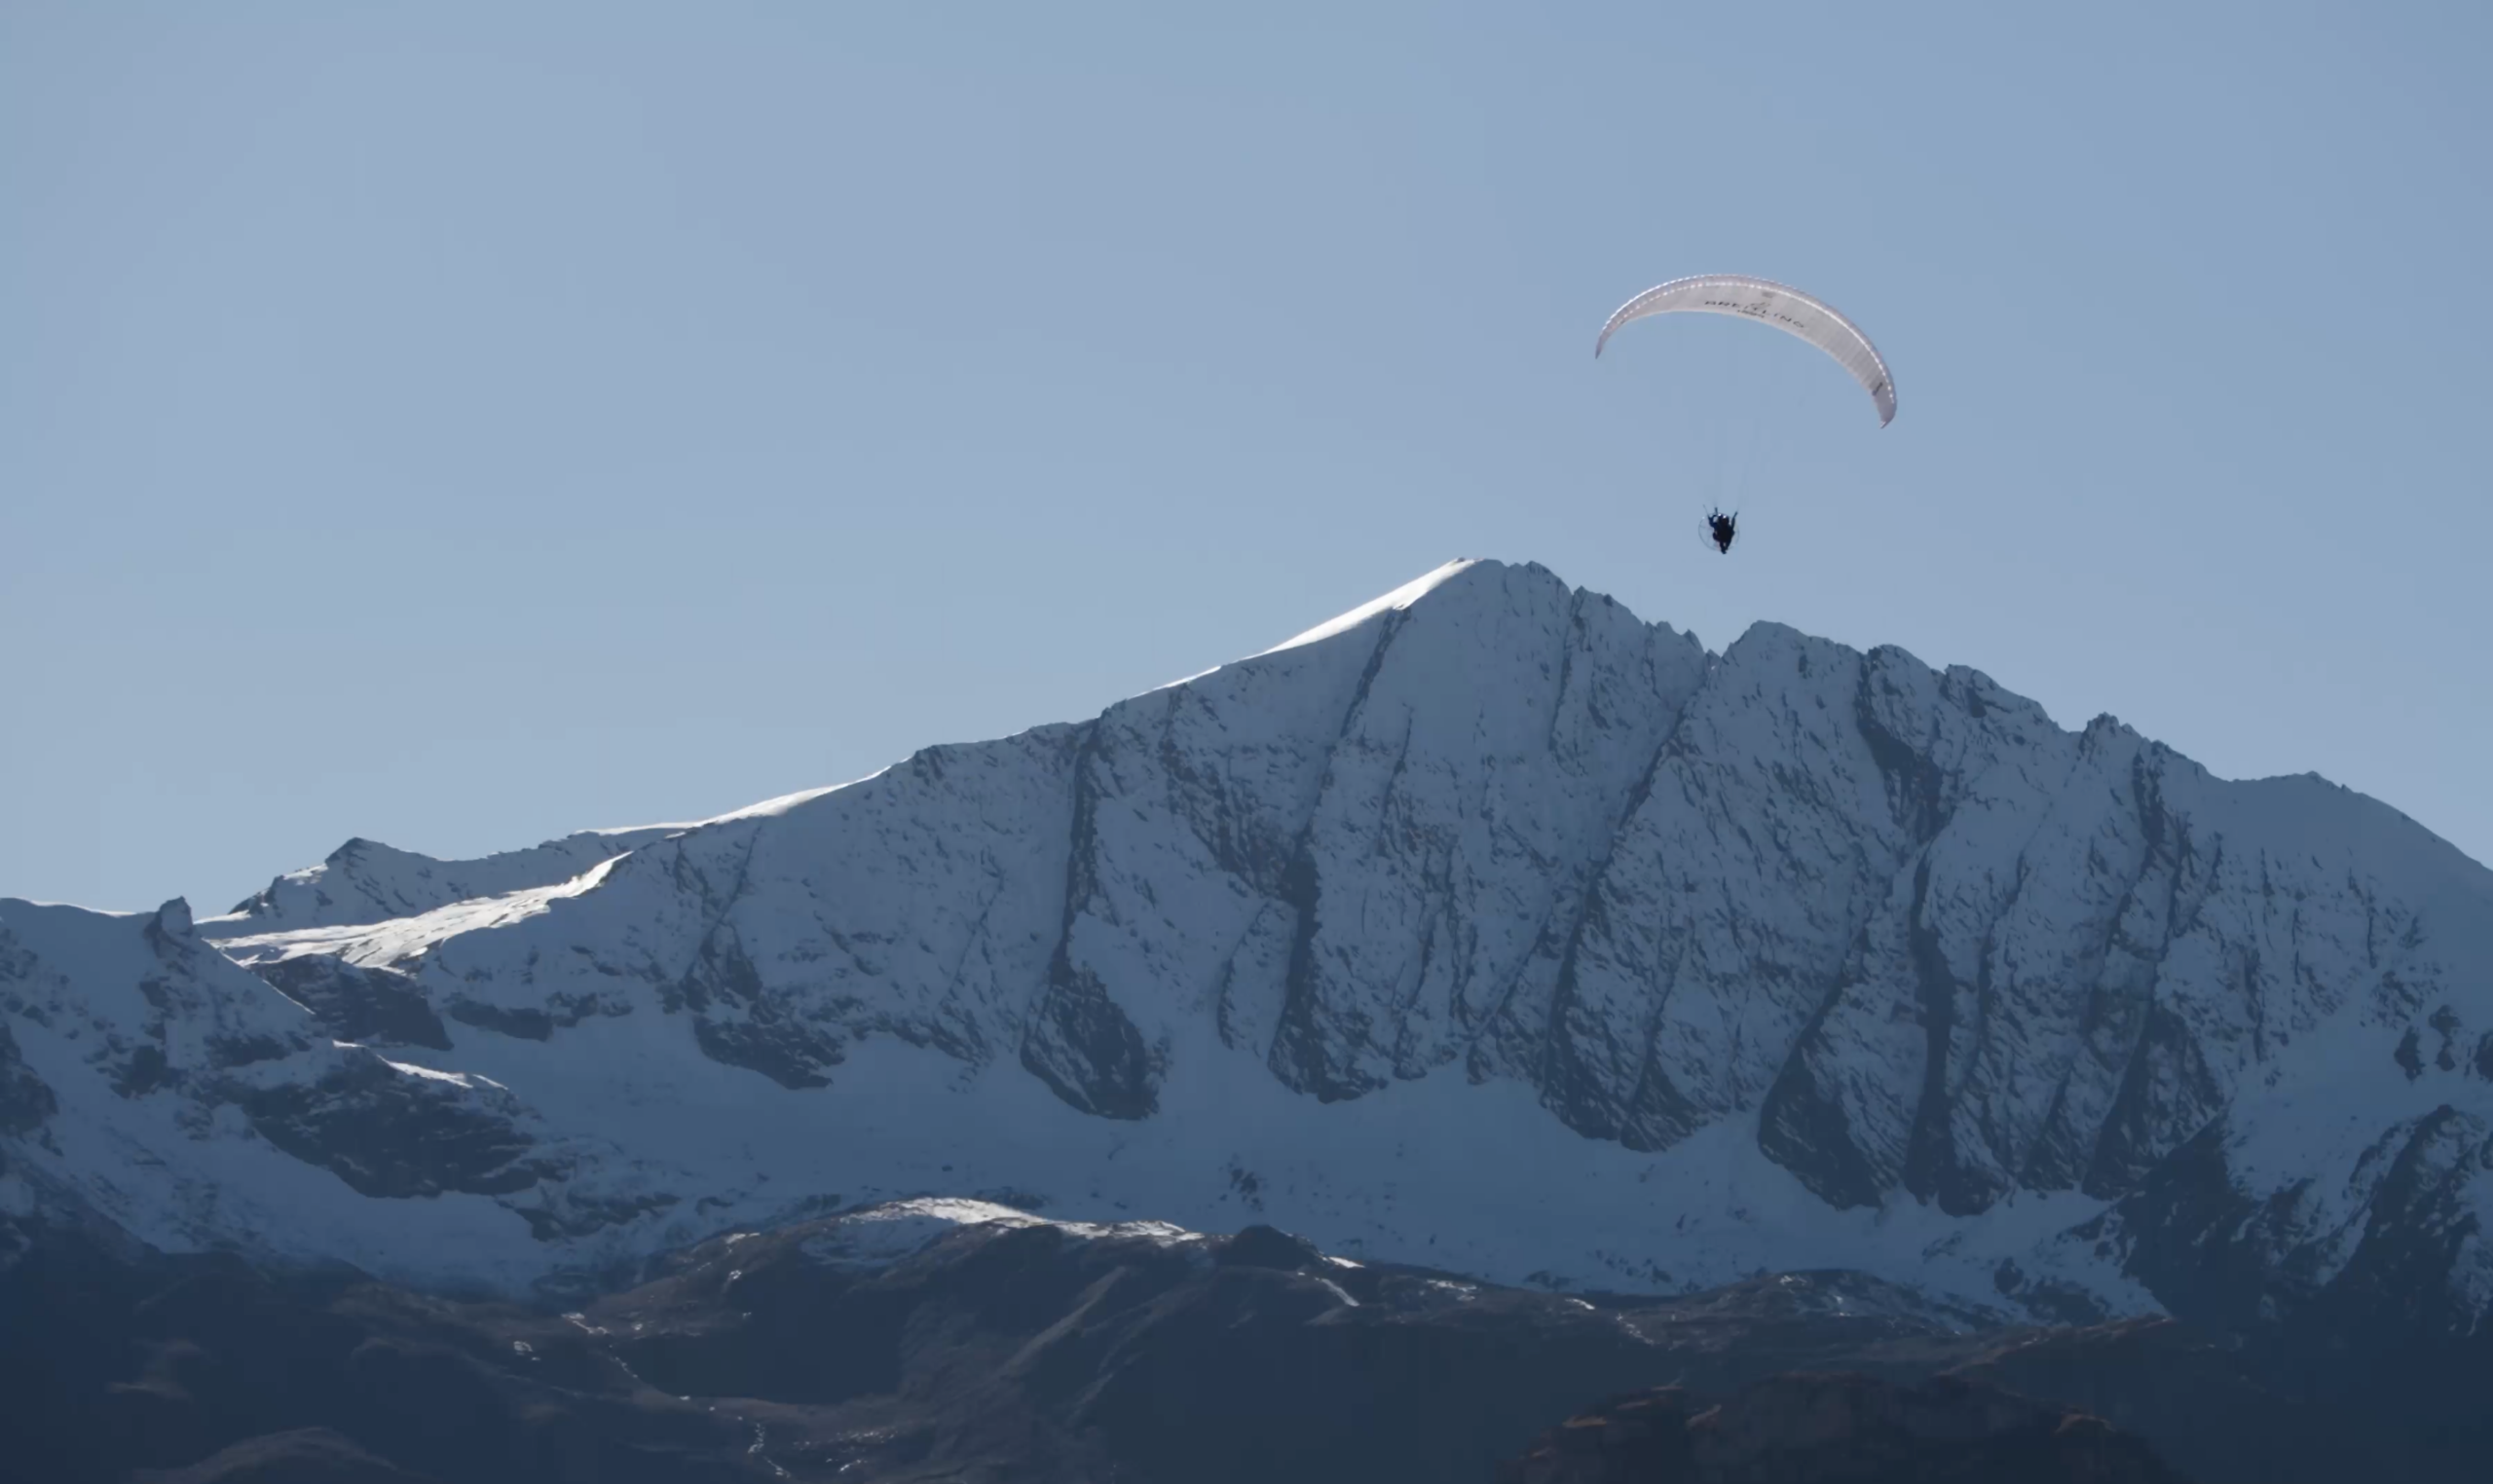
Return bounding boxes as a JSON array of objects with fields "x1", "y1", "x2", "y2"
[{"x1": 0, "y1": 0, "x2": 2493, "y2": 912}]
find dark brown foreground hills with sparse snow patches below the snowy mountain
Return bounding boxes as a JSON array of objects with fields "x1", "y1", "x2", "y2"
[{"x1": 0, "y1": 1214, "x2": 2483, "y2": 1484}]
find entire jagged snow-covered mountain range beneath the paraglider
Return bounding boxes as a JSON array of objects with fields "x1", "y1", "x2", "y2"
[{"x1": 0, "y1": 561, "x2": 2493, "y2": 1332}]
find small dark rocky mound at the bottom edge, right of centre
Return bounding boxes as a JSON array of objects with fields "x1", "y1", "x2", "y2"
[{"x1": 1499, "y1": 1374, "x2": 2181, "y2": 1484}]
